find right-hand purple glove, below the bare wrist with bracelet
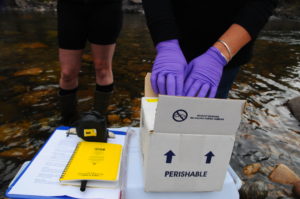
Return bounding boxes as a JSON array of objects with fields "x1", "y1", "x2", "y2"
[{"x1": 184, "y1": 47, "x2": 227, "y2": 98}]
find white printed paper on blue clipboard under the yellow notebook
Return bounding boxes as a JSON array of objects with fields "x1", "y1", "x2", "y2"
[{"x1": 8, "y1": 130, "x2": 125, "y2": 199}]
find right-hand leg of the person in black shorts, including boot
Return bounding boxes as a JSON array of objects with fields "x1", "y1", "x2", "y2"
[{"x1": 88, "y1": 0, "x2": 122, "y2": 114}]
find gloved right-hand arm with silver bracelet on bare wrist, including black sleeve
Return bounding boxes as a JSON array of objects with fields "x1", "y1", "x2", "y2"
[{"x1": 184, "y1": 0, "x2": 277, "y2": 97}]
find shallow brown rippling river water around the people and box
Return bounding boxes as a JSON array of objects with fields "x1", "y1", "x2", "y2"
[{"x1": 0, "y1": 13, "x2": 300, "y2": 198}]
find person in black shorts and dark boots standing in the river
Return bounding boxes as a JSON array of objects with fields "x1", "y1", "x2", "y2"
[{"x1": 57, "y1": 0, "x2": 122, "y2": 125}]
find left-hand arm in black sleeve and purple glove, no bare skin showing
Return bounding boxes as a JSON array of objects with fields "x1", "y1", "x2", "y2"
[{"x1": 143, "y1": 0, "x2": 187, "y2": 95}]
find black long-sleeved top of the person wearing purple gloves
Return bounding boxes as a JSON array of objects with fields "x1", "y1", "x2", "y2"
[{"x1": 143, "y1": 0, "x2": 277, "y2": 65}]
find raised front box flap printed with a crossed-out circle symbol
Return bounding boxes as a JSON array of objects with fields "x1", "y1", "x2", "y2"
[{"x1": 154, "y1": 95, "x2": 245, "y2": 135}]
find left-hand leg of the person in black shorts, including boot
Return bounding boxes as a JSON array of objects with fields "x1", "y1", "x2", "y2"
[{"x1": 57, "y1": 1, "x2": 87, "y2": 126}]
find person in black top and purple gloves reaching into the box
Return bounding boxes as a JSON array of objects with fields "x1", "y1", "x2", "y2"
[{"x1": 142, "y1": 0, "x2": 277, "y2": 98}]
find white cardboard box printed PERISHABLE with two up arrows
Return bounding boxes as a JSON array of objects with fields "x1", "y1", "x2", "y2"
[{"x1": 140, "y1": 74, "x2": 245, "y2": 192}]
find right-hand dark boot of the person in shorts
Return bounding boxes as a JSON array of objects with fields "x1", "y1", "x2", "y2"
[{"x1": 94, "y1": 90, "x2": 112, "y2": 116}]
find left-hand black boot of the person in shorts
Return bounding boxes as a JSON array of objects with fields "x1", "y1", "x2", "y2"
[{"x1": 58, "y1": 93, "x2": 78, "y2": 126}]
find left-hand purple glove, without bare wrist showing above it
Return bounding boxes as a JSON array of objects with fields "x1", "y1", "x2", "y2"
[{"x1": 151, "y1": 39, "x2": 187, "y2": 95}]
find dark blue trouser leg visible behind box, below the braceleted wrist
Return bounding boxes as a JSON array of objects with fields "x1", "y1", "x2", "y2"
[{"x1": 216, "y1": 66, "x2": 240, "y2": 99}]
